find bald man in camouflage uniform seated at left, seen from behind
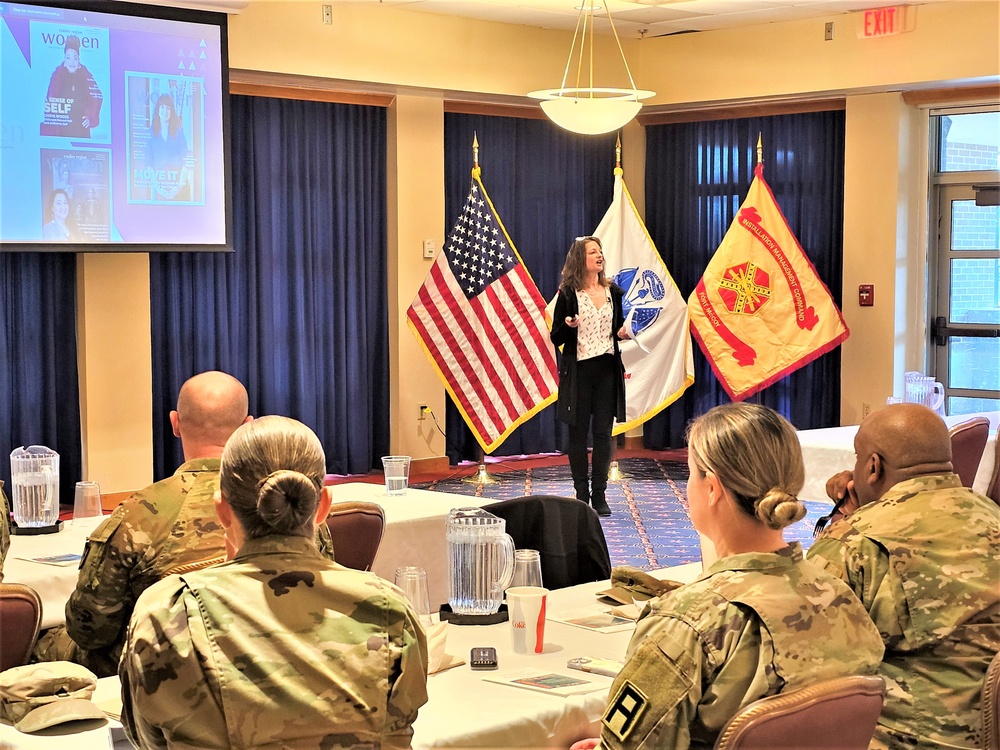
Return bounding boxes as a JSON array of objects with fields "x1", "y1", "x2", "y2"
[{"x1": 35, "y1": 371, "x2": 332, "y2": 677}]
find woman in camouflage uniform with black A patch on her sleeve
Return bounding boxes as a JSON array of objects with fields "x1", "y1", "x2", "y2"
[{"x1": 574, "y1": 404, "x2": 883, "y2": 750}]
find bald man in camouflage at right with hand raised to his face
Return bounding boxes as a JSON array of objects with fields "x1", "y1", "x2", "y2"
[{"x1": 809, "y1": 404, "x2": 1000, "y2": 748}]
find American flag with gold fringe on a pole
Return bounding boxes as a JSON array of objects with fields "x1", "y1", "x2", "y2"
[{"x1": 406, "y1": 168, "x2": 558, "y2": 453}]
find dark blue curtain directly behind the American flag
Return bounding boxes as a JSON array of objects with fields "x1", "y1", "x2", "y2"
[{"x1": 444, "y1": 113, "x2": 616, "y2": 463}]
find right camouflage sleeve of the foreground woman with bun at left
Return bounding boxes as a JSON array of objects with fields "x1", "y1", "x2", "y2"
[{"x1": 386, "y1": 592, "x2": 427, "y2": 736}]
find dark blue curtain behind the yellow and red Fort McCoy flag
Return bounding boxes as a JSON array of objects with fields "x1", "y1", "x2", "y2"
[{"x1": 643, "y1": 111, "x2": 844, "y2": 449}]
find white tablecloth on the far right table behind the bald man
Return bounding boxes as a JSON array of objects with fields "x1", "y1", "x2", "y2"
[{"x1": 798, "y1": 411, "x2": 1000, "y2": 502}]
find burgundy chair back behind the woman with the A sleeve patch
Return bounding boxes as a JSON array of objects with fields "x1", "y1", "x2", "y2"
[{"x1": 715, "y1": 675, "x2": 885, "y2": 750}]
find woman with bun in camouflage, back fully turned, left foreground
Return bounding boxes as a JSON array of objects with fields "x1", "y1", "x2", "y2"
[{"x1": 120, "y1": 417, "x2": 427, "y2": 749}]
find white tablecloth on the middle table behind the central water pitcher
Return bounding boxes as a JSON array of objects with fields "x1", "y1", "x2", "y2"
[{"x1": 330, "y1": 482, "x2": 495, "y2": 610}]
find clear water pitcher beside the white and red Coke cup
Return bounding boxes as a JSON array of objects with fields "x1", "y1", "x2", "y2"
[{"x1": 446, "y1": 508, "x2": 514, "y2": 615}]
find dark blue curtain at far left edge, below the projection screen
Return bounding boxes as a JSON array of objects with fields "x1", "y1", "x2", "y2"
[{"x1": 0, "y1": 253, "x2": 83, "y2": 503}]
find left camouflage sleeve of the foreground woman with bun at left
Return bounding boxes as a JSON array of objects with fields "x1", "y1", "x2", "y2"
[{"x1": 118, "y1": 577, "x2": 228, "y2": 748}]
